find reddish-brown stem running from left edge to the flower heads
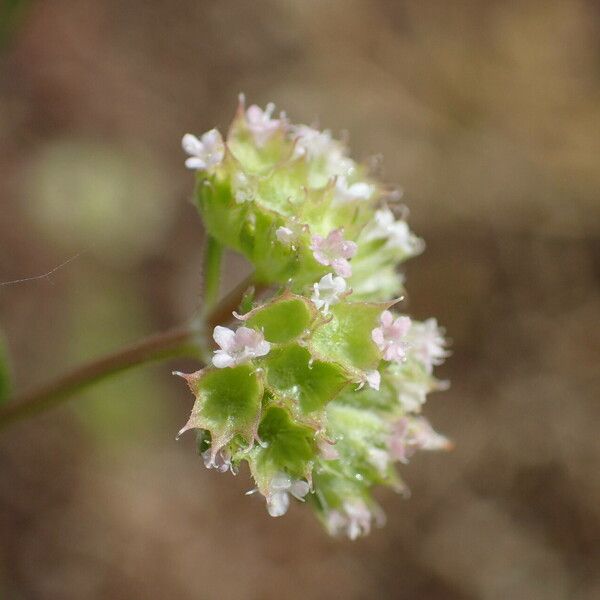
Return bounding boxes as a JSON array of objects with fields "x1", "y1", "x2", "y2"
[{"x1": 0, "y1": 277, "x2": 252, "y2": 429}]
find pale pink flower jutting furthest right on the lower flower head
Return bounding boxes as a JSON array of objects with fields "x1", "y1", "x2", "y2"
[{"x1": 388, "y1": 417, "x2": 452, "y2": 463}]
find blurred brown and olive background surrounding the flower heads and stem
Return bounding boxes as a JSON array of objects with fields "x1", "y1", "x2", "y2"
[{"x1": 0, "y1": 0, "x2": 600, "y2": 600}]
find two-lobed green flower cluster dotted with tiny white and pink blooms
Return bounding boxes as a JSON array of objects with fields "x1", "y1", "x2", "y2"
[{"x1": 180, "y1": 98, "x2": 449, "y2": 539}]
